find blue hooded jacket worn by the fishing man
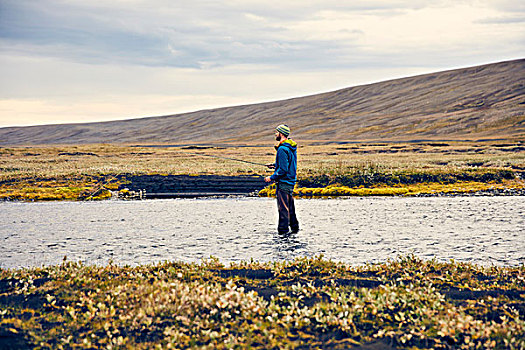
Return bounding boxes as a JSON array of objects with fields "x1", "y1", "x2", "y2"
[{"x1": 270, "y1": 139, "x2": 297, "y2": 186}]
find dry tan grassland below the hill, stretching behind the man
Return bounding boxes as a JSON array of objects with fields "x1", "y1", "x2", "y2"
[{"x1": 0, "y1": 141, "x2": 525, "y2": 199}]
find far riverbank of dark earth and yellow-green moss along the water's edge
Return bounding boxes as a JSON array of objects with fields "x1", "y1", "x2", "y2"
[{"x1": 0, "y1": 170, "x2": 525, "y2": 201}]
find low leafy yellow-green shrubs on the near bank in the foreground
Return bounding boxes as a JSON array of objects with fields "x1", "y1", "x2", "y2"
[{"x1": 0, "y1": 256, "x2": 525, "y2": 349}]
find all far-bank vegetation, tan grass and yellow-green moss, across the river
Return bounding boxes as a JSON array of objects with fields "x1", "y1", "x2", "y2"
[{"x1": 0, "y1": 141, "x2": 525, "y2": 200}]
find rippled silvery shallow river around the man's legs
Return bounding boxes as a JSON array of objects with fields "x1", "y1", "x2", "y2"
[{"x1": 0, "y1": 197, "x2": 525, "y2": 268}]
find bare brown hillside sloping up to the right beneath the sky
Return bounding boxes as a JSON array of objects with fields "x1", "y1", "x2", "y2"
[{"x1": 0, "y1": 59, "x2": 525, "y2": 145}]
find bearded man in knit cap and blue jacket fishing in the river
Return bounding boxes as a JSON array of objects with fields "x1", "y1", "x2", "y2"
[{"x1": 264, "y1": 124, "x2": 299, "y2": 233}]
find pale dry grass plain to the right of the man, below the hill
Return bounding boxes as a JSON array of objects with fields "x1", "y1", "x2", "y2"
[{"x1": 300, "y1": 143, "x2": 525, "y2": 175}]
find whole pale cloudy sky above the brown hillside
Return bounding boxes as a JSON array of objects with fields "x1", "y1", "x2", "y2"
[{"x1": 0, "y1": 0, "x2": 525, "y2": 127}]
